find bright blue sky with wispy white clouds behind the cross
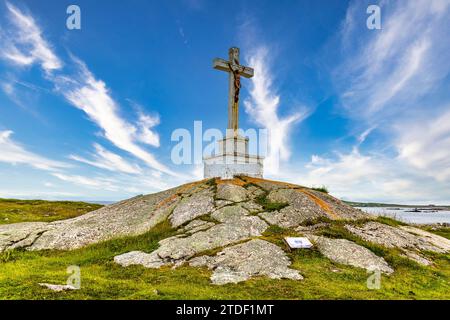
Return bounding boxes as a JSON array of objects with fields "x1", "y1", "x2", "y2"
[{"x1": 0, "y1": 0, "x2": 450, "y2": 203}]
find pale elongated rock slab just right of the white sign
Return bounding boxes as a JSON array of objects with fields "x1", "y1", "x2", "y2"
[{"x1": 308, "y1": 235, "x2": 394, "y2": 274}]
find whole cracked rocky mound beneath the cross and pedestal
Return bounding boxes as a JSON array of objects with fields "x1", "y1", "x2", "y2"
[{"x1": 0, "y1": 177, "x2": 450, "y2": 284}]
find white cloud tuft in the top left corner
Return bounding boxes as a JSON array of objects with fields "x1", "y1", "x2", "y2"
[{"x1": 2, "y1": 2, "x2": 62, "y2": 72}]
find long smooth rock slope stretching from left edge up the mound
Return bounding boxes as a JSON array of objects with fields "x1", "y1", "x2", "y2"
[{"x1": 0, "y1": 189, "x2": 179, "y2": 251}]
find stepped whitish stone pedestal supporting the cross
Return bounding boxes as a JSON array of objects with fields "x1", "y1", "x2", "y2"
[{"x1": 203, "y1": 136, "x2": 264, "y2": 179}]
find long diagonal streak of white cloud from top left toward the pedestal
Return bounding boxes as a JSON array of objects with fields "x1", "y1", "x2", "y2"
[{"x1": 2, "y1": 3, "x2": 175, "y2": 175}]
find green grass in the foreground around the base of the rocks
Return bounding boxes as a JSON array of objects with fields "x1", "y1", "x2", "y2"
[{"x1": 0, "y1": 198, "x2": 450, "y2": 299}]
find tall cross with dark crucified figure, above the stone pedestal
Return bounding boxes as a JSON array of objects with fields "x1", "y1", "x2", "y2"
[{"x1": 213, "y1": 47, "x2": 253, "y2": 136}]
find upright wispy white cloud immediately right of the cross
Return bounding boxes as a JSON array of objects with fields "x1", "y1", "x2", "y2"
[{"x1": 244, "y1": 47, "x2": 308, "y2": 174}]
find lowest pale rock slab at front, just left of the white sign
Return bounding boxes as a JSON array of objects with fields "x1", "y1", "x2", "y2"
[{"x1": 189, "y1": 239, "x2": 303, "y2": 285}]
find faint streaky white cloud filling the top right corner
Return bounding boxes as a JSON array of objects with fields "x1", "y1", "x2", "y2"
[{"x1": 334, "y1": 0, "x2": 450, "y2": 124}]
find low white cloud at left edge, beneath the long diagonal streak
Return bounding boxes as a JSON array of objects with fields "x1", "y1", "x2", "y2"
[{"x1": 0, "y1": 130, "x2": 68, "y2": 171}]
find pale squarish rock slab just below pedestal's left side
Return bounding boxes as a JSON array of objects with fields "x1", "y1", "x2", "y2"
[{"x1": 170, "y1": 189, "x2": 214, "y2": 227}]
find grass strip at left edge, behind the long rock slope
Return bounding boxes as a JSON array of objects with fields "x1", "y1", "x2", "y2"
[{"x1": 0, "y1": 199, "x2": 102, "y2": 224}]
